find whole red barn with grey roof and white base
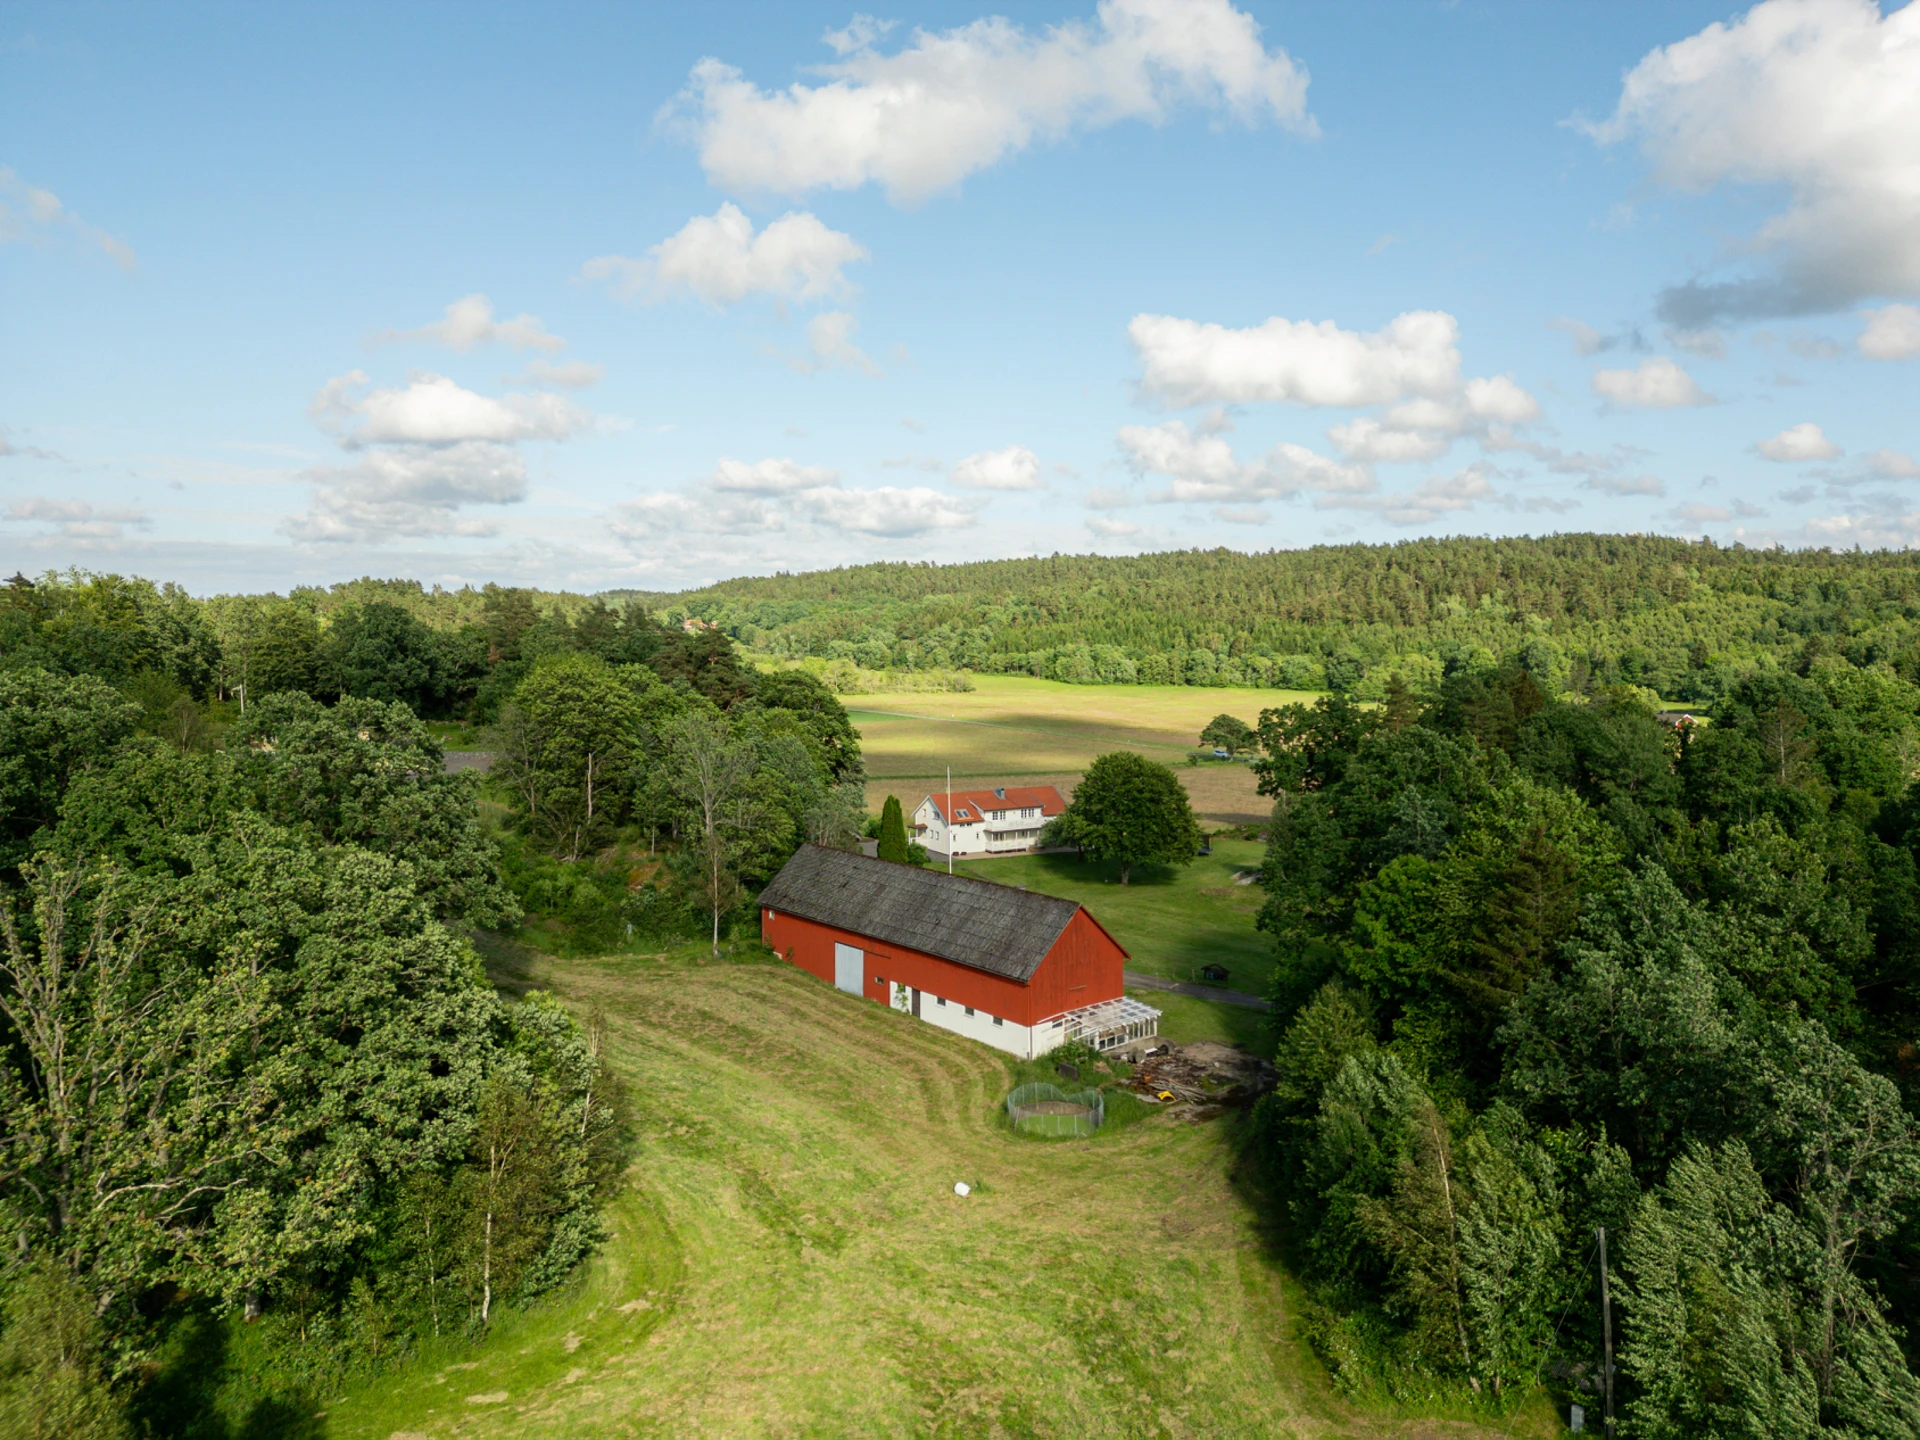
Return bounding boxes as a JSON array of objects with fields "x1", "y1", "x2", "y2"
[{"x1": 760, "y1": 845, "x2": 1160, "y2": 1060}]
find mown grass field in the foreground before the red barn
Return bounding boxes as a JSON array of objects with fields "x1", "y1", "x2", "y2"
[{"x1": 315, "y1": 950, "x2": 1549, "y2": 1440}]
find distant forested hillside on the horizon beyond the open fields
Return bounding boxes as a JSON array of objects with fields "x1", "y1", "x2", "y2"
[{"x1": 645, "y1": 536, "x2": 1920, "y2": 703}]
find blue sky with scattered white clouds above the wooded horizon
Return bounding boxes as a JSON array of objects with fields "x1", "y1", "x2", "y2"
[{"x1": 0, "y1": 0, "x2": 1920, "y2": 593}]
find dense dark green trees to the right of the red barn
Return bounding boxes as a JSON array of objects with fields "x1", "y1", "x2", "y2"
[{"x1": 1258, "y1": 655, "x2": 1920, "y2": 1438}]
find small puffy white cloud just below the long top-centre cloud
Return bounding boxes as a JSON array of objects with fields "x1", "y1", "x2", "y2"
[{"x1": 580, "y1": 204, "x2": 866, "y2": 305}]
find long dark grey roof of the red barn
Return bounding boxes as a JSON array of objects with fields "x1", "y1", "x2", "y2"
[{"x1": 760, "y1": 845, "x2": 1079, "y2": 985}]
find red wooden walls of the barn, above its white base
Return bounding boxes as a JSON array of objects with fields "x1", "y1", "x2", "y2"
[{"x1": 760, "y1": 908, "x2": 1127, "y2": 1025}]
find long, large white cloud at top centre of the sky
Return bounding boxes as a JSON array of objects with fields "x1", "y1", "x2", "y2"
[{"x1": 662, "y1": 0, "x2": 1315, "y2": 202}]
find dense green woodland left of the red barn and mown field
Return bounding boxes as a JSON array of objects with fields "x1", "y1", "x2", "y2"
[{"x1": 0, "y1": 576, "x2": 864, "y2": 1440}]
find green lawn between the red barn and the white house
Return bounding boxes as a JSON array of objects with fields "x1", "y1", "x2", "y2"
[{"x1": 958, "y1": 839, "x2": 1273, "y2": 1054}]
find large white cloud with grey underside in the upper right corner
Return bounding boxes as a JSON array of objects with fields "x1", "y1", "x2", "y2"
[{"x1": 1586, "y1": 0, "x2": 1920, "y2": 328}]
